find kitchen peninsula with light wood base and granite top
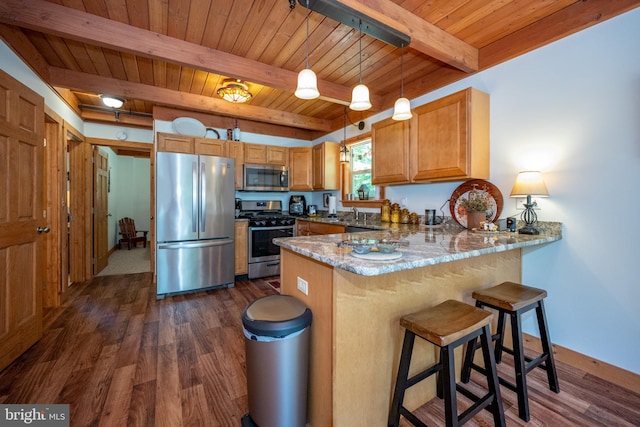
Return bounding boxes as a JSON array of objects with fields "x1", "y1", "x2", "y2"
[{"x1": 274, "y1": 223, "x2": 561, "y2": 427}]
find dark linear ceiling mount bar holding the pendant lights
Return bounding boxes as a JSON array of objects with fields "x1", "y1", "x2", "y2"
[{"x1": 298, "y1": 0, "x2": 411, "y2": 47}]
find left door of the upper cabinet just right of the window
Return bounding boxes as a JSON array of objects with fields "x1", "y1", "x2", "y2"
[{"x1": 371, "y1": 118, "x2": 411, "y2": 184}]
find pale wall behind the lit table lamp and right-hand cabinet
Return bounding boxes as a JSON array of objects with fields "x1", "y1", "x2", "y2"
[{"x1": 322, "y1": 9, "x2": 640, "y2": 373}]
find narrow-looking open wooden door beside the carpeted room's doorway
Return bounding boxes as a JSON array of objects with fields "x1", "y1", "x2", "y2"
[{"x1": 93, "y1": 147, "x2": 109, "y2": 275}]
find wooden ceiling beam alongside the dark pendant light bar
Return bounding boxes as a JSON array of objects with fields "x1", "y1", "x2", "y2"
[{"x1": 336, "y1": 0, "x2": 478, "y2": 72}]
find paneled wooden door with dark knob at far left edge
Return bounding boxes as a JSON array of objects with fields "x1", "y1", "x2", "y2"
[{"x1": 0, "y1": 71, "x2": 46, "y2": 370}]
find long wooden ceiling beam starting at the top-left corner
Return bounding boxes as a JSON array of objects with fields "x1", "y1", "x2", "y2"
[{"x1": 0, "y1": 0, "x2": 381, "y2": 105}]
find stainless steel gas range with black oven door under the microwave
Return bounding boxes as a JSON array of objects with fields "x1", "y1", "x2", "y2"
[{"x1": 239, "y1": 200, "x2": 296, "y2": 279}]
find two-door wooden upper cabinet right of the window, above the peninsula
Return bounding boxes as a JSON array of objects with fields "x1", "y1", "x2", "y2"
[{"x1": 371, "y1": 88, "x2": 489, "y2": 184}]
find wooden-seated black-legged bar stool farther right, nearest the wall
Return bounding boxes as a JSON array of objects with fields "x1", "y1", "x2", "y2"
[{"x1": 462, "y1": 282, "x2": 560, "y2": 421}]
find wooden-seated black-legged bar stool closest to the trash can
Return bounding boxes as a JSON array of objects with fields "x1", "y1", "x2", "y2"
[{"x1": 389, "y1": 300, "x2": 505, "y2": 427}]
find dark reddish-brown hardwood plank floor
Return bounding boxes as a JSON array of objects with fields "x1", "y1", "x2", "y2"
[{"x1": 0, "y1": 273, "x2": 640, "y2": 427}]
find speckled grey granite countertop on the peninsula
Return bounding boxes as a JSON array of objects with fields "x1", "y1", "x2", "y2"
[{"x1": 273, "y1": 224, "x2": 562, "y2": 276}]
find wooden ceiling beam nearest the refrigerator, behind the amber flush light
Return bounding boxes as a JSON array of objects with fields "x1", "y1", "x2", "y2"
[{"x1": 49, "y1": 67, "x2": 331, "y2": 132}]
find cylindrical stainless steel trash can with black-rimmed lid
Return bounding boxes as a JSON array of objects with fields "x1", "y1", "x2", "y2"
[{"x1": 242, "y1": 295, "x2": 312, "y2": 427}]
